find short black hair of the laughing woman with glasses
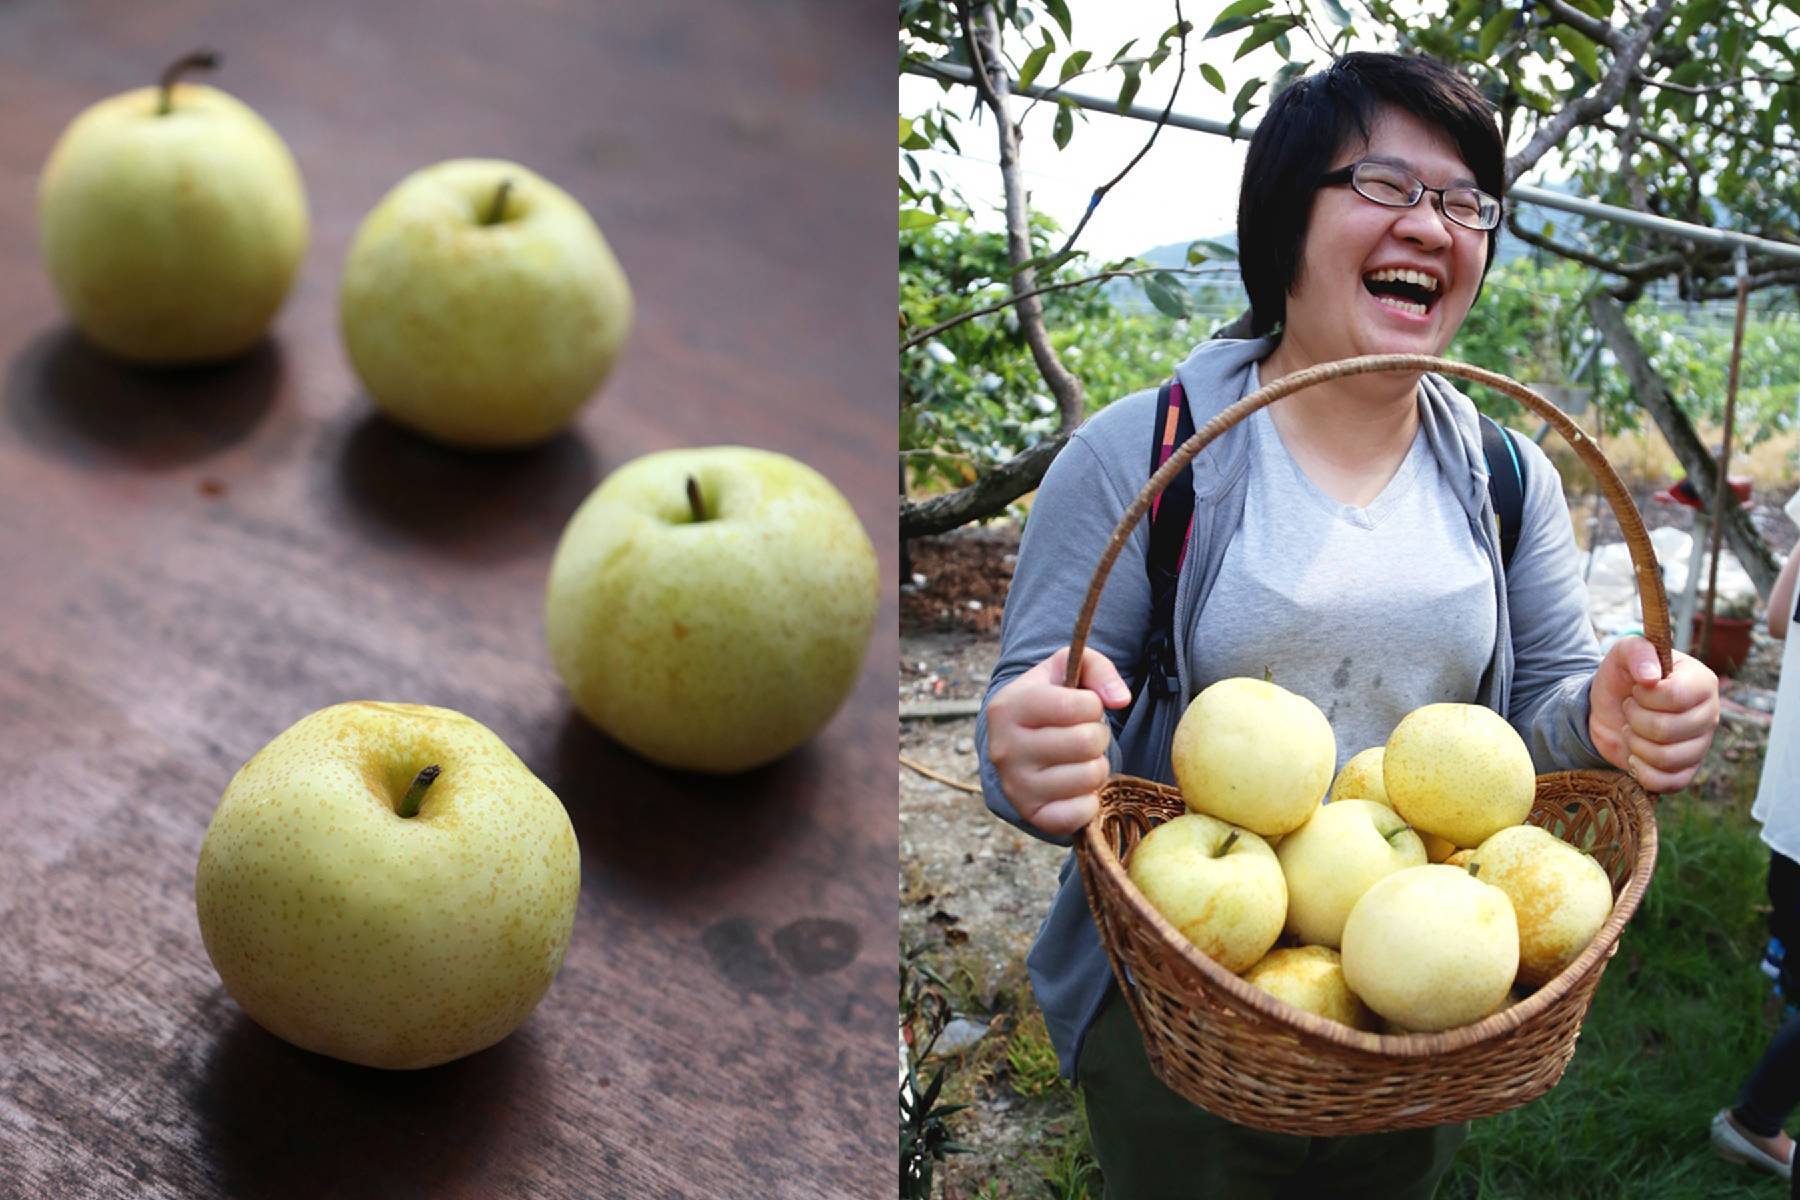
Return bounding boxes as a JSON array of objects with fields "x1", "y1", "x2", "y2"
[{"x1": 1238, "y1": 52, "x2": 1507, "y2": 336}]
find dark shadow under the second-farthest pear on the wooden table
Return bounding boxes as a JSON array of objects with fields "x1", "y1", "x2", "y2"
[{"x1": 338, "y1": 410, "x2": 599, "y2": 561}]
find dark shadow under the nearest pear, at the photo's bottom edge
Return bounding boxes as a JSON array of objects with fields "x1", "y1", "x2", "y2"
[{"x1": 193, "y1": 1011, "x2": 544, "y2": 1200}]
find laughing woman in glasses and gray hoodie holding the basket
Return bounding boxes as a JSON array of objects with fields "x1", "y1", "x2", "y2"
[{"x1": 977, "y1": 54, "x2": 1719, "y2": 1200}]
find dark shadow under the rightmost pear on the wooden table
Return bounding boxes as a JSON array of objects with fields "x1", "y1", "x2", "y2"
[{"x1": 544, "y1": 709, "x2": 830, "y2": 907}]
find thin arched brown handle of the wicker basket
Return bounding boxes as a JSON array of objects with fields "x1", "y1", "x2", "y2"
[{"x1": 1064, "y1": 354, "x2": 1674, "y2": 687}]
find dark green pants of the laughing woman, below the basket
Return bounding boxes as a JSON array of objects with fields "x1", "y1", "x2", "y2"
[{"x1": 1078, "y1": 991, "x2": 1469, "y2": 1200}]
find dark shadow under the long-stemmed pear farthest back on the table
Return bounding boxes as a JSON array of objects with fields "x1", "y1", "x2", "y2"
[{"x1": 5, "y1": 326, "x2": 284, "y2": 471}]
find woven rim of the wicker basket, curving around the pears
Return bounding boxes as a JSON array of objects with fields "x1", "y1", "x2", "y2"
[{"x1": 1080, "y1": 770, "x2": 1656, "y2": 1058}]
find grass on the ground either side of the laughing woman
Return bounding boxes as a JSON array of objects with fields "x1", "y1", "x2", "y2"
[{"x1": 940, "y1": 788, "x2": 1786, "y2": 1200}]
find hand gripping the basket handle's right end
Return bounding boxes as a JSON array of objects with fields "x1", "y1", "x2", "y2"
[{"x1": 1588, "y1": 637, "x2": 1719, "y2": 793}]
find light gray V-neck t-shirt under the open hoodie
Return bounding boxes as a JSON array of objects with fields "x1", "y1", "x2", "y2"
[{"x1": 1188, "y1": 395, "x2": 1496, "y2": 766}]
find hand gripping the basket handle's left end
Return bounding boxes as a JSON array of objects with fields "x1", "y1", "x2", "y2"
[{"x1": 988, "y1": 646, "x2": 1130, "y2": 837}]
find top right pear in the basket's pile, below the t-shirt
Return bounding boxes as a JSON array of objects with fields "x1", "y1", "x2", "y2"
[{"x1": 1381, "y1": 703, "x2": 1537, "y2": 847}]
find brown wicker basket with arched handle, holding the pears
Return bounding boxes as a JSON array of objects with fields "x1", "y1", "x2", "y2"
[{"x1": 1066, "y1": 354, "x2": 1670, "y2": 1135}]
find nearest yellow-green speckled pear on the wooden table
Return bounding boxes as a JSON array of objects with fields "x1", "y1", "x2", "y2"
[{"x1": 194, "y1": 702, "x2": 581, "y2": 1069}]
